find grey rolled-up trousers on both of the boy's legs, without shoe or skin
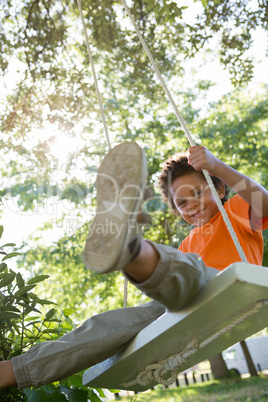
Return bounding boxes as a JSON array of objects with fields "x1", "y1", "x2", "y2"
[{"x1": 12, "y1": 242, "x2": 218, "y2": 389}]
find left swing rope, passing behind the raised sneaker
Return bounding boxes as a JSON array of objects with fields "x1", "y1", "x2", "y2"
[{"x1": 77, "y1": 0, "x2": 128, "y2": 307}]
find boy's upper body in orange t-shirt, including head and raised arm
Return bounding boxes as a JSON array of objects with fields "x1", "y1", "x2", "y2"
[{"x1": 159, "y1": 146, "x2": 268, "y2": 270}]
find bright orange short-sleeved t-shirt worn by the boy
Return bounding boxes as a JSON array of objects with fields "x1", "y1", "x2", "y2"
[{"x1": 179, "y1": 195, "x2": 268, "y2": 271}]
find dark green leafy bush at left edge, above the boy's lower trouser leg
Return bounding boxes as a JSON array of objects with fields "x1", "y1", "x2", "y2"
[{"x1": 0, "y1": 231, "x2": 59, "y2": 360}]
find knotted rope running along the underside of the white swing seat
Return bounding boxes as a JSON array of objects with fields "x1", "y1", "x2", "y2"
[{"x1": 122, "y1": 300, "x2": 268, "y2": 387}]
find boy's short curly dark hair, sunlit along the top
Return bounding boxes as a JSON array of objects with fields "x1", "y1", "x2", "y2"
[{"x1": 159, "y1": 152, "x2": 229, "y2": 215}]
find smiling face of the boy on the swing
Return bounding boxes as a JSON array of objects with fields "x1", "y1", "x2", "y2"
[{"x1": 171, "y1": 173, "x2": 225, "y2": 226}]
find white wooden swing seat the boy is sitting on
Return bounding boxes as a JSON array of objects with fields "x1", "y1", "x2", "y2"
[{"x1": 83, "y1": 262, "x2": 268, "y2": 391}]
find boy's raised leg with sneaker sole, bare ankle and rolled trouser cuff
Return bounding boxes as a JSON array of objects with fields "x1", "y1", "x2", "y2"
[{"x1": 84, "y1": 142, "x2": 218, "y2": 310}]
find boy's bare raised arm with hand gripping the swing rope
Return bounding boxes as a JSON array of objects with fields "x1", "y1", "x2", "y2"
[{"x1": 188, "y1": 146, "x2": 268, "y2": 220}]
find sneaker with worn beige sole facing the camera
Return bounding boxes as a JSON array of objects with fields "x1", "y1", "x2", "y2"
[{"x1": 83, "y1": 142, "x2": 147, "y2": 273}]
